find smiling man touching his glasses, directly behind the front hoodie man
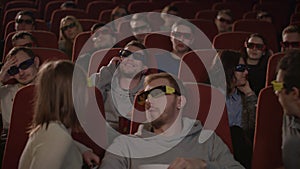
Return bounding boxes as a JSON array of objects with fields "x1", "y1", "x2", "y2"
[{"x1": 95, "y1": 41, "x2": 147, "y2": 132}]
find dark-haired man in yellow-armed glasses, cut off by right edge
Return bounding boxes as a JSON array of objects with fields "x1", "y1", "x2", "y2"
[{"x1": 272, "y1": 50, "x2": 300, "y2": 169}]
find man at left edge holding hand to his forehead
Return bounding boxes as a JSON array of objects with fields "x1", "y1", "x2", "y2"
[{"x1": 0, "y1": 47, "x2": 39, "y2": 166}]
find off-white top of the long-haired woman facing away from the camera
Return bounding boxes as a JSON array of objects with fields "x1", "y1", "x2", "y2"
[{"x1": 19, "y1": 122, "x2": 83, "y2": 169}]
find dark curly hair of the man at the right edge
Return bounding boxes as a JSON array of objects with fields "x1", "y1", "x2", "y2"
[{"x1": 277, "y1": 49, "x2": 300, "y2": 93}]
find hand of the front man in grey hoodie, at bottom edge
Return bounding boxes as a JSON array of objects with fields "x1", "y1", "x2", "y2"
[{"x1": 168, "y1": 158, "x2": 206, "y2": 169}]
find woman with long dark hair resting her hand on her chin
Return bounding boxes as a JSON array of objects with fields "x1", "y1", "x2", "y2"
[{"x1": 212, "y1": 50, "x2": 257, "y2": 169}]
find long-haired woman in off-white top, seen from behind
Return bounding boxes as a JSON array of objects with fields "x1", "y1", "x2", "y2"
[{"x1": 19, "y1": 61, "x2": 99, "y2": 169}]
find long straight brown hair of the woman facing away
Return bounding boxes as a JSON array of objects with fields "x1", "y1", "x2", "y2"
[{"x1": 32, "y1": 60, "x2": 86, "y2": 131}]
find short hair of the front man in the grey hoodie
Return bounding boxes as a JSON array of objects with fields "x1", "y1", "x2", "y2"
[{"x1": 144, "y1": 72, "x2": 185, "y2": 95}]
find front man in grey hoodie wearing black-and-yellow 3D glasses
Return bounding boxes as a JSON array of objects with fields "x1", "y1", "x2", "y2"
[{"x1": 100, "y1": 73, "x2": 243, "y2": 169}]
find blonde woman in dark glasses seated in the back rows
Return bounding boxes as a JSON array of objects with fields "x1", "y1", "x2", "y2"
[{"x1": 58, "y1": 16, "x2": 82, "y2": 58}]
